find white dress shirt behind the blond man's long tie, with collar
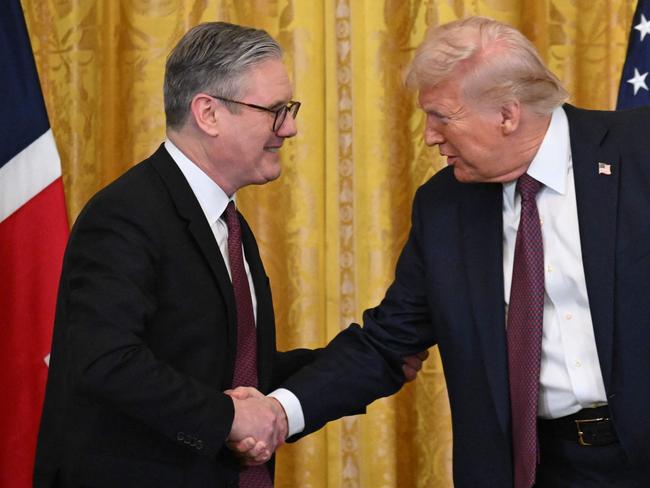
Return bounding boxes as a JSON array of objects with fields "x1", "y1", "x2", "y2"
[{"x1": 503, "y1": 108, "x2": 606, "y2": 418}]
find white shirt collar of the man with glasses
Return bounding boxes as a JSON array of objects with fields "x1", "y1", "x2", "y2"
[{"x1": 165, "y1": 139, "x2": 235, "y2": 225}]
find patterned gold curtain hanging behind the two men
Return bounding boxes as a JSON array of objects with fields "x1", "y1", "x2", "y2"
[{"x1": 22, "y1": 0, "x2": 636, "y2": 488}]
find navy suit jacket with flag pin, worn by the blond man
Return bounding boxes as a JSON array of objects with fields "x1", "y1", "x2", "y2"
[{"x1": 285, "y1": 106, "x2": 650, "y2": 488}]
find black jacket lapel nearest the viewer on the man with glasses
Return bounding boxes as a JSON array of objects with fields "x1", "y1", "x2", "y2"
[{"x1": 150, "y1": 145, "x2": 237, "y2": 364}]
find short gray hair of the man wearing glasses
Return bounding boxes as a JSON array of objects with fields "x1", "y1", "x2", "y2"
[{"x1": 163, "y1": 22, "x2": 282, "y2": 128}]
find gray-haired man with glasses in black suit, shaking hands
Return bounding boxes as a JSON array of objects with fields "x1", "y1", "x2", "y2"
[{"x1": 34, "y1": 22, "x2": 316, "y2": 488}]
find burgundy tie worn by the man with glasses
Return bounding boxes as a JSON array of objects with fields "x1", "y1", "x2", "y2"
[{"x1": 224, "y1": 201, "x2": 273, "y2": 488}]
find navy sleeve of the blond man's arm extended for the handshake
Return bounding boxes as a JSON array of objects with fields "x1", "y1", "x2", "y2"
[{"x1": 283, "y1": 189, "x2": 435, "y2": 435}]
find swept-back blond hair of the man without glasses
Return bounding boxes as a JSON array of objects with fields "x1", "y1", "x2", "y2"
[{"x1": 406, "y1": 17, "x2": 568, "y2": 115}]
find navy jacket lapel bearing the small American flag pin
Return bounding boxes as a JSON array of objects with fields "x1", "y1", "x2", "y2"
[{"x1": 564, "y1": 105, "x2": 620, "y2": 392}]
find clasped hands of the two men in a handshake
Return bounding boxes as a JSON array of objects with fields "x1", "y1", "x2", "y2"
[{"x1": 225, "y1": 386, "x2": 289, "y2": 466}]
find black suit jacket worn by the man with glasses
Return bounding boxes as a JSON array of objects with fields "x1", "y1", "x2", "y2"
[{"x1": 34, "y1": 146, "x2": 313, "y2": 488}]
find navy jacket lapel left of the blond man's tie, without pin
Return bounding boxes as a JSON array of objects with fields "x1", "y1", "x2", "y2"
[{"x1": 460, "y1": 184, "x2": 510, "y2": 435}]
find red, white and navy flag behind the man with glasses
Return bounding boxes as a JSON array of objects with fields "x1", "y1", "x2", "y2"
[{"x1": 0, "y1": 0, "x2": 68, "y2": 488}]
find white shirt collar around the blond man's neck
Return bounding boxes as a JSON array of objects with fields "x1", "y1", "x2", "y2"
[{"x1": 503, "y1": 107, "x2": 572, "y2": 206}]
